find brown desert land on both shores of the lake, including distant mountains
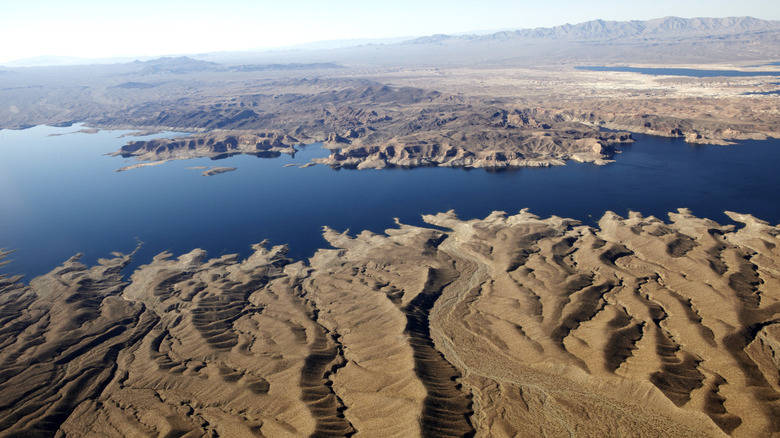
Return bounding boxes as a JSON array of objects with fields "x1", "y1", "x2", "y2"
[{"x1": 0, "y1": 18, "x2": 780, "y2": 437}]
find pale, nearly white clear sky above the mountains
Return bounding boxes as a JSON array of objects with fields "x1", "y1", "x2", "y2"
[{"x1": 0, "y1": 0, "x2": 780, "y2": 62}]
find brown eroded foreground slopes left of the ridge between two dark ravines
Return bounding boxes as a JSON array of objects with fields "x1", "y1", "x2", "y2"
[{"x1": 2, "y1": 245, "x2": 332, "y2": 436}]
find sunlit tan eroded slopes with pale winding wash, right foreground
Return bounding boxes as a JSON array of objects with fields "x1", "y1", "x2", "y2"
[{"x1": 426, "y1": 210, "x2": 780, "y2": 436}]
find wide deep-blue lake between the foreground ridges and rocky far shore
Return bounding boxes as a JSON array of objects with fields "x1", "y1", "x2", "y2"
[{"x1": 0, "y1": 126, "x2": 780, "y2": 278}]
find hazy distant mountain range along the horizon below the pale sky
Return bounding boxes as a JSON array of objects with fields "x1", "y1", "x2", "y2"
[{"x1": 4, "y1": 17, "x2": 780, "y2": 67}]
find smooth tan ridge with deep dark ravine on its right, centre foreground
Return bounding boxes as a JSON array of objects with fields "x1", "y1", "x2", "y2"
[{"x1": 312, "y1": 226, "x2": 475, "y2": 437}]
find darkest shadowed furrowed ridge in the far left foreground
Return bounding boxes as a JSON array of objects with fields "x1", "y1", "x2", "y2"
[{"x1": 0, "y1": 252, "x2": 156, "y2": 436}]
